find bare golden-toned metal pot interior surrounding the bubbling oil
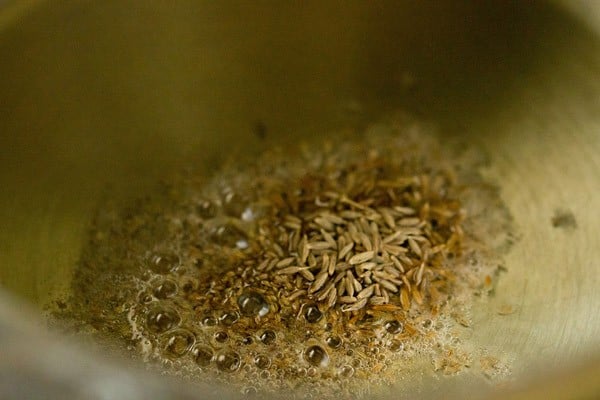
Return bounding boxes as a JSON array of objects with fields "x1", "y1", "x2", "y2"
[{"x1": 0, "y1": 1, "x2": 600, "y2": 398}]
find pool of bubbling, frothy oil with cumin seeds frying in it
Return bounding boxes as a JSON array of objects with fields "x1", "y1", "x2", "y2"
[{"x1": 56, "y1": 115, "x2": 510, "y2": 397}]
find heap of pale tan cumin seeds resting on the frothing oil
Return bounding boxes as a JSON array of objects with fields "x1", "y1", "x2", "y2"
[{"x1": 256, "y1": 180, "x2": 462, "y2": 312}]
